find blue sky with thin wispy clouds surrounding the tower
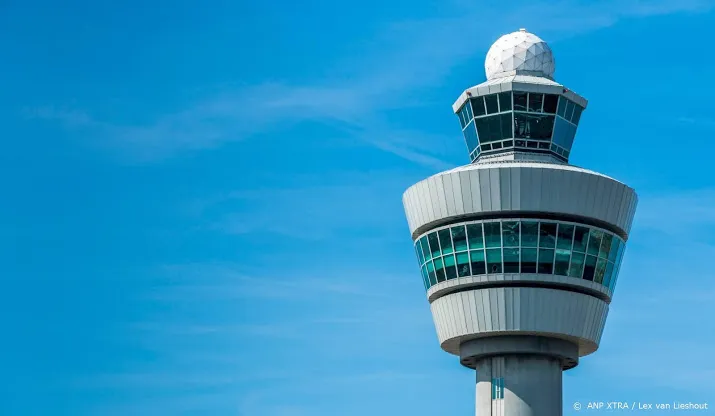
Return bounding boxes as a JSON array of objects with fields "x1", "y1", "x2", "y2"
[{"x1": 0, "y1": 0, "x2": 715, "y2": 416}]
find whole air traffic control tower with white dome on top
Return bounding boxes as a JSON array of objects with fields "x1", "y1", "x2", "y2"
[{"x1": 403, "y1": 29, "x2": 638, "y2": 416}]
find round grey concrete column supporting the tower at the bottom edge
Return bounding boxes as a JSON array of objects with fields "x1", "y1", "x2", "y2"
[{"x1": 476, "y1": 355, "x2": 563, "y2": 416}]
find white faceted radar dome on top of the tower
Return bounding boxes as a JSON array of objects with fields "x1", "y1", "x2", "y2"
[{"x1": 484, "y1": 29, "x2": 556, "y2": 79}]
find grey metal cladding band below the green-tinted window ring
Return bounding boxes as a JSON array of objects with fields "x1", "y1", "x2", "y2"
[{"x1": 431, "y1": 287, "x2": 608, "y2": 356}]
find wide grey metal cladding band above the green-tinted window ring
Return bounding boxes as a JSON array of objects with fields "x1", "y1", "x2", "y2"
[{"x1": 403, "y1": 162, "x2": 637, "y2": 237}]
